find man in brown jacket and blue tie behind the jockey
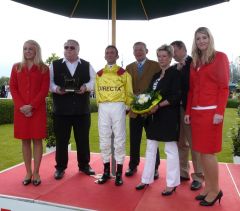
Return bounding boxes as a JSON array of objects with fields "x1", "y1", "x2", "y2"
[{"x1": 125, "y1": 42, "x2": 160, "y2": 179}]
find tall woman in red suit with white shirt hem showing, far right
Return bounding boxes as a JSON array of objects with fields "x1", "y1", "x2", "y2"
[{"x1": 185, "y1": 27, "x2": 229, "y2": 206}]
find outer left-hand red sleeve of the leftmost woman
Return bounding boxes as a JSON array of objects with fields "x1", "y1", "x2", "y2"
[{"x1": 10, "y1": 64, "x2": 25, "y2": 110}]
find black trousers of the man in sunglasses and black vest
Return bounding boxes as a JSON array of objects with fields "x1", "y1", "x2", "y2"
[{"x1": 53, "y1": 114, "x2": 91, "y2": 170}]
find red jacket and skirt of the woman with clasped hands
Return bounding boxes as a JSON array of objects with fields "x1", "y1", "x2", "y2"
[{"x1": 10, "y1": 64, "x2": 50, "y2": 139}]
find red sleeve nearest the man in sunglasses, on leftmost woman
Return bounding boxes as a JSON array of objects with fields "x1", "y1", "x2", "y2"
[{"x1": 30, "y1": 69, "x2": 50, "y2": 109}]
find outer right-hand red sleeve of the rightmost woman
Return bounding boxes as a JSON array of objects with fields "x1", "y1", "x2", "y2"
[{"x1": 216, "y1": 53, "x2": 230, "y2": 115}]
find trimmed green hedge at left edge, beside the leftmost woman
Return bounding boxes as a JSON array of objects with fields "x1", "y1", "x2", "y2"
[{"x1": 0, "y1": 99, "x2": 13, "y2": 125}]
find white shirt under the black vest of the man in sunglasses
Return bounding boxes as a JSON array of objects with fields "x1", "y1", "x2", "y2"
[{"x1": 49, "y1": 58, "x2": 96, "y2": 92}]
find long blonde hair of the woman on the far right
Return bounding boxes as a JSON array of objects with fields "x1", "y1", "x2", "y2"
[{"x1": 192, "y1": 27, "x2": 216, "y2": 68}]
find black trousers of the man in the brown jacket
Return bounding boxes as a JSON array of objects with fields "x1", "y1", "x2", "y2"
[{"x1": 129, "y1": 115, "x2": 160, "y2": 170}]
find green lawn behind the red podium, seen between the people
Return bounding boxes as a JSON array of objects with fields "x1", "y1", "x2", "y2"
[{"x1": 0, "y1": 108, "x2": 237, "y2": 170}]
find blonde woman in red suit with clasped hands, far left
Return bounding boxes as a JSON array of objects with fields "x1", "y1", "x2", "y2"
[{"x1": 10, "y1": 40, "x2": 49, "y2": 186}]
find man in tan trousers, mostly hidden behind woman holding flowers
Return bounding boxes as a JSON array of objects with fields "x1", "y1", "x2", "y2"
[{"x1": 171, "y1": 41, "x2": 203, "y2": 190}]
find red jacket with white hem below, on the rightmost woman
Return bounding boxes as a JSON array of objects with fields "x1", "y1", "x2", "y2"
[{"x1": 186, "y1": 52, "x2": 229, "y2": 115}]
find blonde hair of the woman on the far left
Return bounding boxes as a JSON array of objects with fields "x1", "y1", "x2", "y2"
[{"x1": 17, "y1": 40, "x2": 48, "y2": 72}]
